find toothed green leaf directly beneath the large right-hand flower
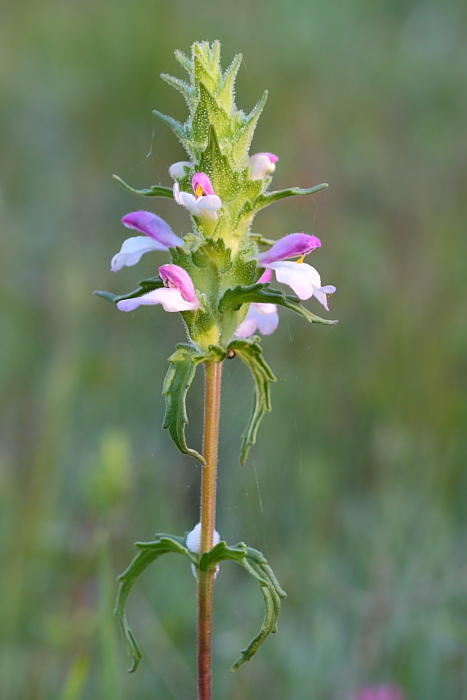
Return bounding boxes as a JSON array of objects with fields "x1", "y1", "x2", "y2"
[{"x1": 219, "y1": 282, "x2": 337, "y2": 326}]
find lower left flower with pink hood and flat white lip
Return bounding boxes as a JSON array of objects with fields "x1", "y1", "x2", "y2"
[{"x1": 117, "y1": 264, "x2": 199, "y2": 312}]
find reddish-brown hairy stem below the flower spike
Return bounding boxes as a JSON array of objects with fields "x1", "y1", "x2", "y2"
[{"x1": 198, "y1": 362, "x2": 222, "y2": 700}]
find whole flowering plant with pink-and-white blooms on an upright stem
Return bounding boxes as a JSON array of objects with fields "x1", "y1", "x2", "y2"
[{"x1": 96, "y1": 42, "x2": 336, "y2": 700}]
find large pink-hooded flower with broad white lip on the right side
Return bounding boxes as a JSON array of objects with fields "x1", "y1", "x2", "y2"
[{"x1": 257, "y1": 233, "x2": 336, "y2": 311}]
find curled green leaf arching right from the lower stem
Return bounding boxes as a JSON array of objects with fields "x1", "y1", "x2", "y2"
[{"x1": 199, "y1": 542, "x2": 286, "y2": 673}]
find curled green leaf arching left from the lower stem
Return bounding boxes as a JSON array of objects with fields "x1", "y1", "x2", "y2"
[{"x1": 114, "y1": 534, "x2": 194, "y2": 673}]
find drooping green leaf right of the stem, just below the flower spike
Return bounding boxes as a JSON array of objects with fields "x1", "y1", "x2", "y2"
[{"x1": 228, "y1": 336, "x2": 276, "y2": 465}]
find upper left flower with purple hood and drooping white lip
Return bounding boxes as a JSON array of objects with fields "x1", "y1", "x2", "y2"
[{"x1": 110, "y1": 211, "x2": 183, "y2": 272}]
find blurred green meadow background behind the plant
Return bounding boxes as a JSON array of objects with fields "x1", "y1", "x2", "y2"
[{"x1": 0, "y1": 0, "x2": 467, "y2": 700}]
